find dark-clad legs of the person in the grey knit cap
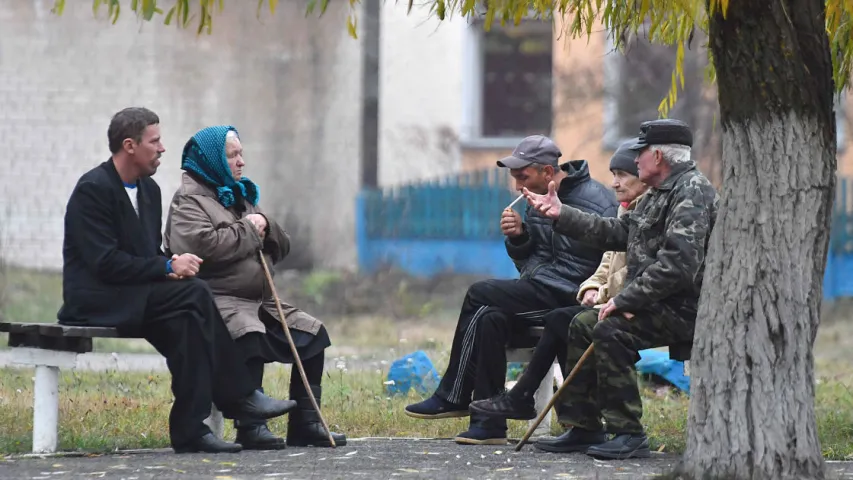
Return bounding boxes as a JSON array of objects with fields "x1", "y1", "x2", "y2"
[{"x1": 510, "y1": 305, "x2": 591, "y2": 398}]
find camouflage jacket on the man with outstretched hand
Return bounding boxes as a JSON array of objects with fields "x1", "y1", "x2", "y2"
[{"x1": 554, "y1": 161, "x2": 717, "y2": 320}]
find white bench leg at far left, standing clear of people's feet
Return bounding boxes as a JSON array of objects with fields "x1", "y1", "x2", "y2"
[{"x1": 33, "y1": 365, "x2": 59, "y2": 453}]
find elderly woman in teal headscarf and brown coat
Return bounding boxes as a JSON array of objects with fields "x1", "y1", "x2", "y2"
[{"x1": 163, "y1": 125, "x2": 346, "y2": 450}]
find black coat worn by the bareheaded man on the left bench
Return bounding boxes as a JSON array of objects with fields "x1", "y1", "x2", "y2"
[{"x1": 58, "y1": 159, "x2": 171, "y2": 329}]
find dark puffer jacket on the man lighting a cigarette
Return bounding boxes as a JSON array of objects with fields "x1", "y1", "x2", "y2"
[{"x1": 505, "y1": 160, "x2": 619, "y2": 302}]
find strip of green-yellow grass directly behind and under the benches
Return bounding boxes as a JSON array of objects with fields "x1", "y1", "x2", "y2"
[{"x1": 0, "y1": 366, "x2": 853, "y2": 460}]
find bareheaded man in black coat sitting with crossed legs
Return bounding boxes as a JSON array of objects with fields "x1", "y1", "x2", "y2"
[{"x1": 58, "y1": 108, "x2": 296, "y2": 453}]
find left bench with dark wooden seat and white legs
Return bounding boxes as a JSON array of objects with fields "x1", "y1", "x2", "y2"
[{"x1": 0, "y1": 323, "x2": 224, "y2": 453}]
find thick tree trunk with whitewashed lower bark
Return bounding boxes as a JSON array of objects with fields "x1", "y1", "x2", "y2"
[{"x1": 678, "y1": 0, "x2": 836, "y2": 479}]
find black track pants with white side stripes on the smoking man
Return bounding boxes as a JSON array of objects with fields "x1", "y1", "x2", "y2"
[{"x1": 436, "y1": 279, "x2": 577, "y2": 405}]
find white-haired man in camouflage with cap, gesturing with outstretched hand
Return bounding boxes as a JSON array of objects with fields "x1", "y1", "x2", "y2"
[{"x1": 524, "y1": 120, "x2": 717, "y2": 459}]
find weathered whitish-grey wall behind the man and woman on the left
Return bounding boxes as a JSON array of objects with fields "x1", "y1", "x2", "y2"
[{"x1": 0, "y1": 0, "x2": 361, "y2": 269}]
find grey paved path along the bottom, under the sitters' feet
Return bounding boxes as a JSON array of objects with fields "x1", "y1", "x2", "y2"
[{"x1": 0, "y1": 438, "x2": 678, "y2": 480}]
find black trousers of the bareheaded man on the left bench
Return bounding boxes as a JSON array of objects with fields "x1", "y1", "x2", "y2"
[{"x1": 137, "y1": 278, "x2": 255, "y2": 447}]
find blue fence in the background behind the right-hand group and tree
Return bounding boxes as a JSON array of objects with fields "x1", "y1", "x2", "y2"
[{"x1": 355, "y1": 169, "x2": 853, "y2": 299}]
